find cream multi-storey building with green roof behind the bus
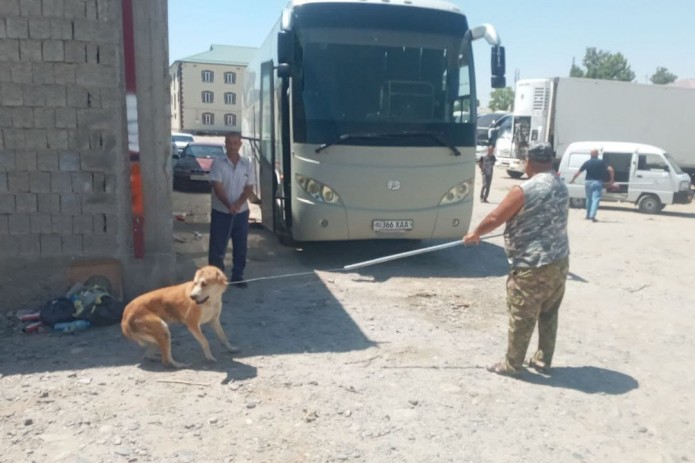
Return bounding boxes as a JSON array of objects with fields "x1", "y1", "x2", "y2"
[{"x1": 169, "y1": 44, "x2": 257, "y2": 135}]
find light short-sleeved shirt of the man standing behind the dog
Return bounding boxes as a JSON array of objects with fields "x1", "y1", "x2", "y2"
[{"x1": 209, "y1": 156, "x2": 256, "y2": 214}]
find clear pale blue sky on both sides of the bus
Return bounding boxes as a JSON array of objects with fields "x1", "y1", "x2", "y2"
[{"x1": 169, "y1": 0, "x2": 695, "y2": 105}]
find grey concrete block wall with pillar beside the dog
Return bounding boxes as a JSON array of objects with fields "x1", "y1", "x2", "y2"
[{"x1": 0, "y1": 0, "x2": 174, "y2": 312}]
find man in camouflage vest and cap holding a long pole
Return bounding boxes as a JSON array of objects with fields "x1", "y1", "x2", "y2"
[{"x1": 463, "y1": 144, "x2": 569, "y2": 375}]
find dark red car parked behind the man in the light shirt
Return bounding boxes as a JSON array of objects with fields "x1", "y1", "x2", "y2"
[{"x1": 174, "y1": 142, "x2": 227, "y2": 190}]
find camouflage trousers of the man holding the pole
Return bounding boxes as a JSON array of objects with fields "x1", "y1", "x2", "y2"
[{"x1": 506, "y1": 257, "x2": 569, "y2": 371}]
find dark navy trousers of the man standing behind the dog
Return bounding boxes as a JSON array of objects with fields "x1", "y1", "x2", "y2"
[{"x1": 208, "y1": 209, "x2": 249, "y2": 279}]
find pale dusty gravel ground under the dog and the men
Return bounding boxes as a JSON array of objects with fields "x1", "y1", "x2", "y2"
[{"x1": 0, "y1": 172, "x2": 695, "y2": 463}]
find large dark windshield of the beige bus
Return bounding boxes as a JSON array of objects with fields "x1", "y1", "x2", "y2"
[{"x1": 293, "y1": 27, "x2": 476, "y2": 146}]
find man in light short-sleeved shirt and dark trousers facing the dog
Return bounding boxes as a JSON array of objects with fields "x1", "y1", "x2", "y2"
[{"x1": 208, "y1": 132, "x2": 256, "y2": 288}]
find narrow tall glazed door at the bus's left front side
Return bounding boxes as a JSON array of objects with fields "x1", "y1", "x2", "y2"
[{"x1": 258, "y1": 61, "x2": 280, "y2": 232}]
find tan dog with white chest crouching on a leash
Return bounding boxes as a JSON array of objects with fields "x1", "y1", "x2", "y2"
[{"x1": 121, "y1": 265, "x2": 239, "y2": 368}]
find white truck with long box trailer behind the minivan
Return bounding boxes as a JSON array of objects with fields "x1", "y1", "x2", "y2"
[{"x1": 496, "y1": 77, "x2": 695, "y2": 180}]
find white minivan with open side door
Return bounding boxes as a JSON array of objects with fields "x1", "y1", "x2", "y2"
[{"x1": 558, "y1": 141, "x2": 693, "y2": 214}]
